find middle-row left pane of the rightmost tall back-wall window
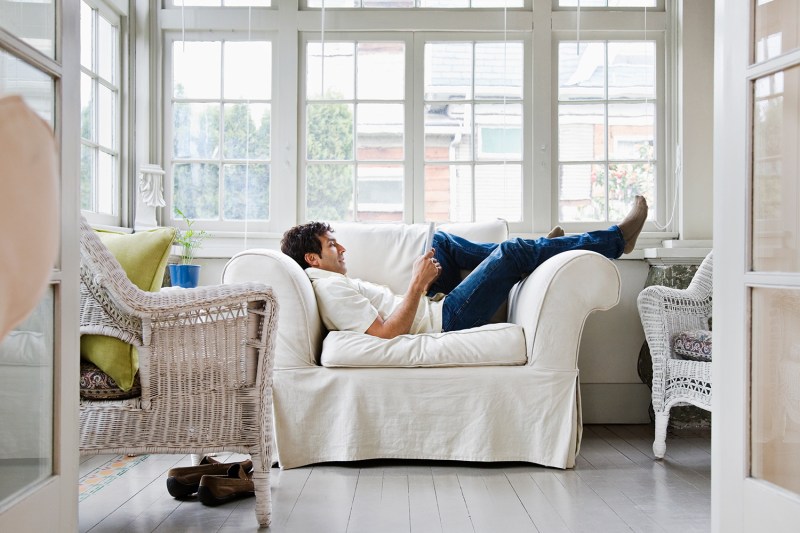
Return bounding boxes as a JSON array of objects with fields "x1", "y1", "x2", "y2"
[{"x1": 558, "y1": 104, "x2": 606, "y2": 161}]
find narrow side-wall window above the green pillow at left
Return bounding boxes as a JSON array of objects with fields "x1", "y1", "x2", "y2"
[{"x1": 80, "y1": 2, "x2": 122, "y2": 225}]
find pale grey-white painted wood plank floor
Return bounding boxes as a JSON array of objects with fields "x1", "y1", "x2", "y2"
[{"x1": 79, "y1": 425, "x2": 711, "y2": 533}]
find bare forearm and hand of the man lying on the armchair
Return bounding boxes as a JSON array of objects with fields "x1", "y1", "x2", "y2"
[{"x1": 364, "y1": 248, "x2": 442, "y2": 339}]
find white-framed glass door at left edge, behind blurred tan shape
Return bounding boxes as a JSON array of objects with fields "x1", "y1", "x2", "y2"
[{"x1": 0, "y1": 0, "x2": 80, "y2": 531}]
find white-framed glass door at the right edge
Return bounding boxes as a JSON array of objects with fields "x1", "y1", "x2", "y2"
[{"x1": 712, "y1": 0, "x2": 800, "y2": 533}]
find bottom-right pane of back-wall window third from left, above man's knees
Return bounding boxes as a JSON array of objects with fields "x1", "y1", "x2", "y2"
[{"x1": 475, "y1": 164, "x2": 522, "y2": 222}]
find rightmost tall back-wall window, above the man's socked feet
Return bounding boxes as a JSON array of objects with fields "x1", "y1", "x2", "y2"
[{"x1": 558, "y1": 41, "x2": 658, "y2": 222}]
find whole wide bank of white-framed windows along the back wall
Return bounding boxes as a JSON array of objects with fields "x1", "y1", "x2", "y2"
[{"x1": 160, "y1": 0, "x2": 678, "y2": 234}]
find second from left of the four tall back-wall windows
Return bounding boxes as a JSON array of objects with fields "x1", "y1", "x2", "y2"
[{"x1": 305, "y1": 40, "x2": 408, "y2": 221}]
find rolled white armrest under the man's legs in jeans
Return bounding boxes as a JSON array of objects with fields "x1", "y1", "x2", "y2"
[{"x1": 508, "y1": 251, "x2": 621, "y2": 370}]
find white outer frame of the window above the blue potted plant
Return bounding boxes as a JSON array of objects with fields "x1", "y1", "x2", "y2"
[{"x1": 162, "y1": 30, "x2": 283, "y2": 234}]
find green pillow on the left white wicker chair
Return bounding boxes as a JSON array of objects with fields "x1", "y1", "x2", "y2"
[{"x1": 81, "y1": 228, "x2": 175, "y2": 391}]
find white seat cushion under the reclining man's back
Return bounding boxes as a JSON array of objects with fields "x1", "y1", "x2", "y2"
[{"x1": 321, "y1": 324, "x2": 527, "y2": 368}]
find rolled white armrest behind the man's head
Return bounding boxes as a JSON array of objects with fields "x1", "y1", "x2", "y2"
[{"x1": 222, "y1": 249, "x2": 325, "y2": 369}]
